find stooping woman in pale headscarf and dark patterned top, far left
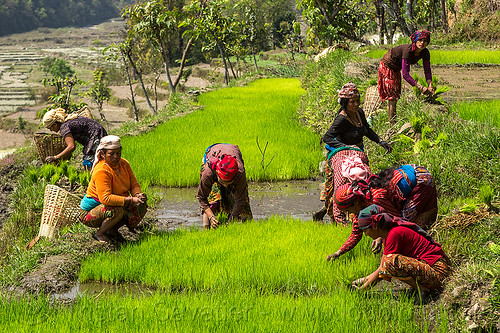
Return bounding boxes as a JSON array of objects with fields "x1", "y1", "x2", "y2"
[{"x1": 43, "y1": 108, "x2": 108, "y2": 170}]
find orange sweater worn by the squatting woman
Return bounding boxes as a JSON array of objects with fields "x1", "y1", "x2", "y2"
[{"x1": 87, "y1": 158, "x2": 141, "y2": 206}]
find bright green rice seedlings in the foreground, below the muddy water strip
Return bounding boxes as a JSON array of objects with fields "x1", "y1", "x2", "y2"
[{"x1": 0, "y1": 217, "x2": 449, "y2": 332}]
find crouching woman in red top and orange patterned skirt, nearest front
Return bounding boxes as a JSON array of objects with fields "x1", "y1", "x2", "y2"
[{"x1": 352, "y1": 205, "x2": 451, "y2": 289}]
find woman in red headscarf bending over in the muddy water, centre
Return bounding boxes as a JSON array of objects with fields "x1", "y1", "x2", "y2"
[{"x1": 196, "y1": 143, "x2": 253, "y2": 229}]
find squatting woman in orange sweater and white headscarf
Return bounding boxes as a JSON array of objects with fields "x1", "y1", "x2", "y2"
[{"x1": 80, "y1": 135, "x2": 148, "y2": 243}]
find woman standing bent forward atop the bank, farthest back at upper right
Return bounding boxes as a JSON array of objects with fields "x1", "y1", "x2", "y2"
[{"x1": 378, "y1": 30, "x2": 434, "y2": 123}]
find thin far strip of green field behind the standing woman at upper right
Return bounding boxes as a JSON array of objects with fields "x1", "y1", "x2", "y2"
[{"x1": 366, "y1": 49, "x2": 500, "y2": 65}]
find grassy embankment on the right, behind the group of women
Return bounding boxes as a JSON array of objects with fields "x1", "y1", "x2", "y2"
[{"x1": 299, "y1": 48, "x2": 500, "y2": 329}]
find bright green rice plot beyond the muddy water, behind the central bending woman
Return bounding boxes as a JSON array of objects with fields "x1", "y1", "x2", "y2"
[{"x1": 122, "y1": 79, "x2": 322, "y2": 186}]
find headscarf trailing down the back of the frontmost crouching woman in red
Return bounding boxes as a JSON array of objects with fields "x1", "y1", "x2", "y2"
[{"x1": 358, "y1": 205, "x2": 441, "y2": 241}]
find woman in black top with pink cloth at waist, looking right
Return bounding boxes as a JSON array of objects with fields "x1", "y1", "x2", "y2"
[{"x1": 313, "y1": 82, "x2": 392, "y2": 225}]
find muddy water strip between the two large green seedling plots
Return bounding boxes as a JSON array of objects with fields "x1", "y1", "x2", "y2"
[{"x1": 155, "y1": 180, "x2": 322, "y2": 231}]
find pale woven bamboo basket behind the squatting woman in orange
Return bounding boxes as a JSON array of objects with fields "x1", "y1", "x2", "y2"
[{"x1": 38, "y1": 185, "x2": 81, "y2": 238}]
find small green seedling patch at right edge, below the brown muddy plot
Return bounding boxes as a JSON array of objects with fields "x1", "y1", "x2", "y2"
[{"x1": 450, "y1": 99, "x2": 500, "y2": 127}]
